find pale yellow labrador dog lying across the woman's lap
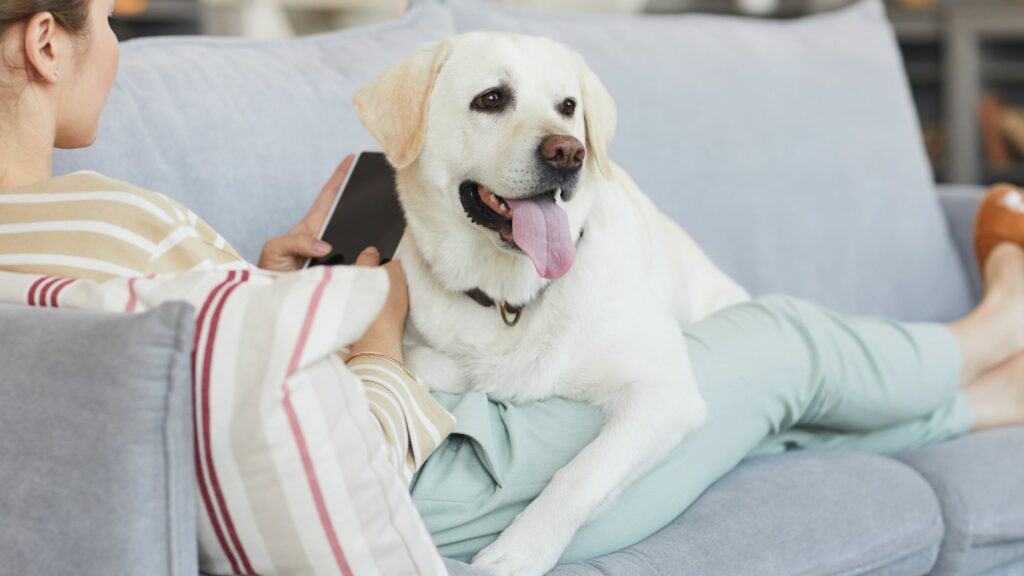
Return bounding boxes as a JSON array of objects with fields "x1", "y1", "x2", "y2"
[{"x1": 355, "y1": 33, "x2": 748, "y2": 576}]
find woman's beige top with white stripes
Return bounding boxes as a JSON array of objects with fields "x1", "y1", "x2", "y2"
[{"x1": 0, "y1": 172, "x2": 455, "y2": 484}]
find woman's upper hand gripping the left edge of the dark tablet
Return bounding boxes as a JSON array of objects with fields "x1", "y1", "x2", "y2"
[{"x1": 258, "y1": 154, "x2": 355, "y2": 272}]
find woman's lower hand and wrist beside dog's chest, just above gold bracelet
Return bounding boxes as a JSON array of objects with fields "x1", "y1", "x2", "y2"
[{"x1": 349, "y1": 246, "x2": 409, "y2": 362}]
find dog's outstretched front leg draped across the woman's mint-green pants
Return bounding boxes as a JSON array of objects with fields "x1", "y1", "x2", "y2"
[{"x1": 473, "y1": 365, "x2": 707, "y2": 576}]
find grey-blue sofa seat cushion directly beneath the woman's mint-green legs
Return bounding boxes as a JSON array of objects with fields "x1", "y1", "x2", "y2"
[{"x1": 449, "y1": 452, "x2": 943, "y2": 576}]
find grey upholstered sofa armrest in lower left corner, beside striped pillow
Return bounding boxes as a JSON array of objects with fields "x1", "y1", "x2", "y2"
[{"x1": 0, "y1": 303, "x2": 198, "y2": 576}]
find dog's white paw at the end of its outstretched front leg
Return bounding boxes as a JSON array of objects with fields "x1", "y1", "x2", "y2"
[{"x1": 472, "y1": 521, "x2": 572, "y2": 576}]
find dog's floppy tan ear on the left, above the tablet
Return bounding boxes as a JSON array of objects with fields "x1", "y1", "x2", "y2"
[{"x1": 352, "y1": 40, "x2": 451, "y2": 170}]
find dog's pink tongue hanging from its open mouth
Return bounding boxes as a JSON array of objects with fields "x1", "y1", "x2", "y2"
[{"x1": 505, "y1": 195, "x2": 575, "y2": 280}]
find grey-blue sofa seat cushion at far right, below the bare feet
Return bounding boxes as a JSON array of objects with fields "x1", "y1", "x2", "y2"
[{"x1": 902, "y1": 427, "x2": 1024, "y2": 576}]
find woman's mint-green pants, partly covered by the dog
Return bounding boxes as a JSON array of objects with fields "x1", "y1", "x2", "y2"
[{"x1": 412, "y1": 296, "x2": 974, "y2": 562}]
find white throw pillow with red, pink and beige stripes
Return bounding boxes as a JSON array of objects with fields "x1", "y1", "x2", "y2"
[{"x1": 0, "y1": 266, "x2": 445, "y2": 576}]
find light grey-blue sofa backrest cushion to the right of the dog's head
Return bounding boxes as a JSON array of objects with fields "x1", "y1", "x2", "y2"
[{"x1": 446, "y1": 0, "x2": 970, "y2": 319}]
